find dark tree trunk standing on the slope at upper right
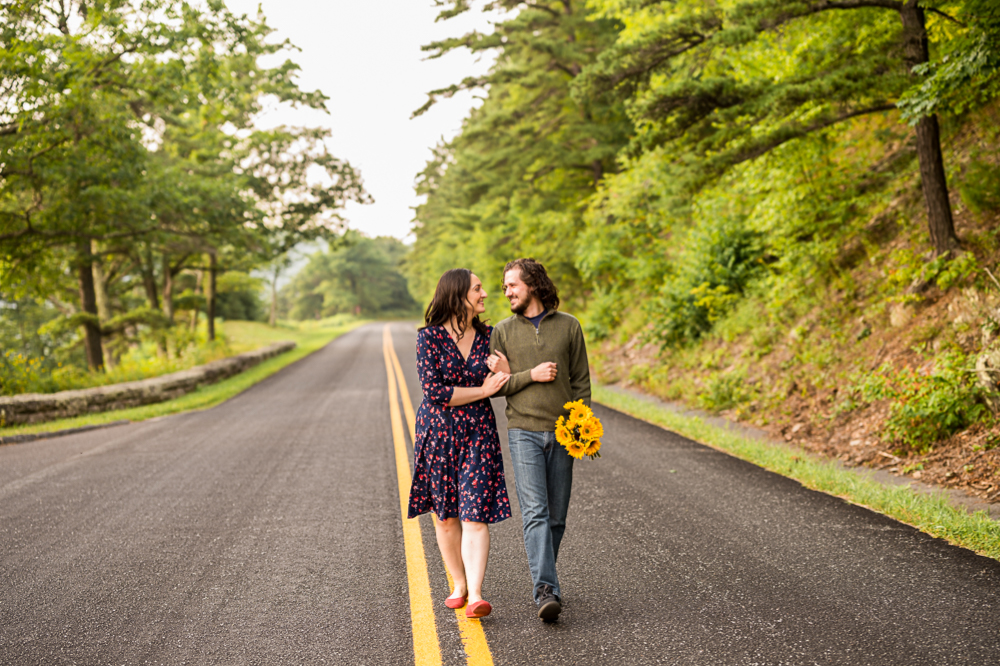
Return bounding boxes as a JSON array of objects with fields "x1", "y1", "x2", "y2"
[{"x1": 900, "y1": 0, "x2": 961, "y2": 255}]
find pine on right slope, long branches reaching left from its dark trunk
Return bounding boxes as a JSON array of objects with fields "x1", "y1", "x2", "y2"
[{"x1": 580, "y1": 0, "x2": 972, "y2": 254}]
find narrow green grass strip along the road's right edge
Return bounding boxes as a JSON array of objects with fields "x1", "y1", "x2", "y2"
[{"x1": 594, "y1": 385, "x2": 1000, "y2": 560}]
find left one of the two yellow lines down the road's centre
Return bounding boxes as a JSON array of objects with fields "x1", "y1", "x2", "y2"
[{"x1": 382, "y1": 324, "x2": 441, "y2": 666}]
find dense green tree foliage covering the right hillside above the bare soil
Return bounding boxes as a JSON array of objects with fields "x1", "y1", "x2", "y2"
[{"x1": 409, "y1": 0, "x2": 1000, "y2": 338}]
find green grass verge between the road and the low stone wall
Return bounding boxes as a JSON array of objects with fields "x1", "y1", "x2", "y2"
[{"x1": 0, "y1": 318, "x2": 365, "y2": 437}]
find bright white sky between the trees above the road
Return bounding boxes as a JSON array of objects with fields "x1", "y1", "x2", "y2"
[{"x1": 226, "y1": 0, "x2": 492, "y2": 240}]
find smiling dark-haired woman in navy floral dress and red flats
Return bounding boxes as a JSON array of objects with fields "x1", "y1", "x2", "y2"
[{"x1": 408, "y1": 268, "x2": 510, "y2": 618}]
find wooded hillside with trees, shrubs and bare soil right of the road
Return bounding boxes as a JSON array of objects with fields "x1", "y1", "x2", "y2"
[{"x1": 407, "y1": 0, "x2": 1000, "y2": 501}]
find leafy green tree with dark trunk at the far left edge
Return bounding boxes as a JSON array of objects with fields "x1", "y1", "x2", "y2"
[{"x1": 0, "y1": 3, "x2": 145, "y2": 369}]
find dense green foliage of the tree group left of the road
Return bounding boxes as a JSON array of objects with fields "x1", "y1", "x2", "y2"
[{"x1": 0, "y1": 0, "x2": 368, "y2": 392}]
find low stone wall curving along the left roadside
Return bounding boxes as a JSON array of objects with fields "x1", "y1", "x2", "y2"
[{"x1": 0, "y1": 342, "x2": 295, "y2": 425}]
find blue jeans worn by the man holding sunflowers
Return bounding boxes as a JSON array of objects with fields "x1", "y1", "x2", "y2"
[{"x1": 507, "y1": 429, "x2": 573, "y2": 601}]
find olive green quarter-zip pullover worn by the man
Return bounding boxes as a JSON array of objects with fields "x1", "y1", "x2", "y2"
[{"x1": 490, "y1": 311, "x2": 590, "y2": 432}]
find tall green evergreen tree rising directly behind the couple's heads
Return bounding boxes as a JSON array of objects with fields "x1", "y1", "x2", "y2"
[{"x1": 407, "y1": 0, "x2": 631, "y2": 313}]
